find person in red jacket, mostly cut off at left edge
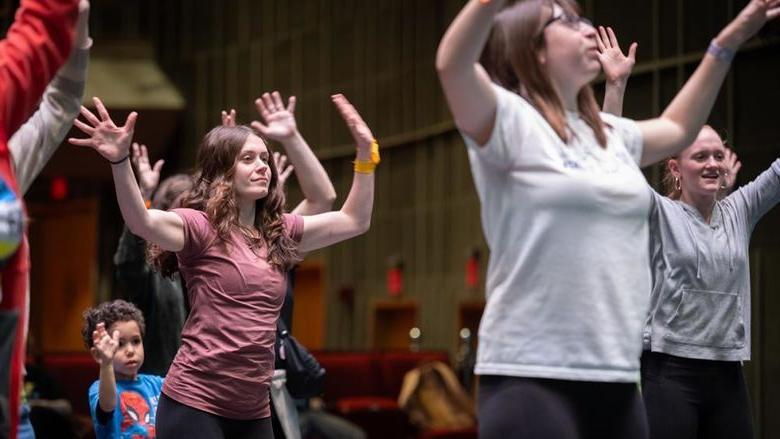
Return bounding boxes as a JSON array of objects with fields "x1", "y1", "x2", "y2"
[{"x1": 0, "y1": 0, "x2": 79, "y2": 439}]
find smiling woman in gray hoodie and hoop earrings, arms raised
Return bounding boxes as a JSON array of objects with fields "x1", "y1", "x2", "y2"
[{"x1": 599, "y1": 28, "x2": 780, "y2": 439}]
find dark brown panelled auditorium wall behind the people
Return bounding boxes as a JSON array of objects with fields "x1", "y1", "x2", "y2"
[{"x1": 106, "y1": 0, "x2": 780, "y2": 438}]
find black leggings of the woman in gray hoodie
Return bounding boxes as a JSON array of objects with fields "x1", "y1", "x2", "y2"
[{"x1": 642, "y1": 352, "x2": 753, "y2": 439}]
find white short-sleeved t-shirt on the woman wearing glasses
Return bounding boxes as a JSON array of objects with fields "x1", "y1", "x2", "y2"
[{"x1": 464, "y1": 86, "x2": 651, "y2": 382}]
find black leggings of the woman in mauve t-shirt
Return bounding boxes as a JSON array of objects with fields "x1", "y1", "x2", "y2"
[{"x1": 156, "y1": 393, "x2": 274, "y2": 439}]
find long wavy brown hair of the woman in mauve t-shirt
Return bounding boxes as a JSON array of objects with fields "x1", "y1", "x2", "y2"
[{"x1": 149, "y1": 125, "x2": 299, "y2": 276}]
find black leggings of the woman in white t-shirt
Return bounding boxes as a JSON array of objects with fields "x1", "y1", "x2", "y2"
[{"x1": 478, "y1": 375, "x2": 648, "y2": 439}]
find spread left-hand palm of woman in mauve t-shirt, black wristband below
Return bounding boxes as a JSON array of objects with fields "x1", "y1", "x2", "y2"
[{"x1": 68, "y1": 98, "x2": 138, "y2": 162}]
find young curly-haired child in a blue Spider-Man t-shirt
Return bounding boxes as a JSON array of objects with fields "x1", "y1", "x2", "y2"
[{"x1": 81, "y1": 300, "x2": 163, "y2": 439}]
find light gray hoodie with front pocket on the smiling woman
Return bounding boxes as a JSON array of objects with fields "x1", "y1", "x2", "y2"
[{"x1": 643, "y1": 160, "x2": 780, "y2": 361}]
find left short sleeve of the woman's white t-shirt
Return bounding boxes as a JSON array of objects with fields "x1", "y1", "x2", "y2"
[{"x1": 461, "y1": 84, "x2": 536, "y2": 169}]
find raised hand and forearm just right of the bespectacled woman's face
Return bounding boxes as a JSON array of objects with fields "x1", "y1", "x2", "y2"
[{"x1": 596, "y1": 26, "x2": 637, "y2": 116}]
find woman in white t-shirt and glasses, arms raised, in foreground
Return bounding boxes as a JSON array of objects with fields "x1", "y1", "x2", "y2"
[{"x1": 436, "y1": 0, "x2": 780, "y2": 439}]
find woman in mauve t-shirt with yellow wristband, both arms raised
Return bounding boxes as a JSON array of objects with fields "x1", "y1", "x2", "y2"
[{"x1": 71, "y1": 94, "x2": 379, "y2": 438}]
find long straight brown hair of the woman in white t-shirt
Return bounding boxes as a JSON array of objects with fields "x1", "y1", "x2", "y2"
[{"x1": 480, "y1": 0, "x2": 607, "y2": 147}]
